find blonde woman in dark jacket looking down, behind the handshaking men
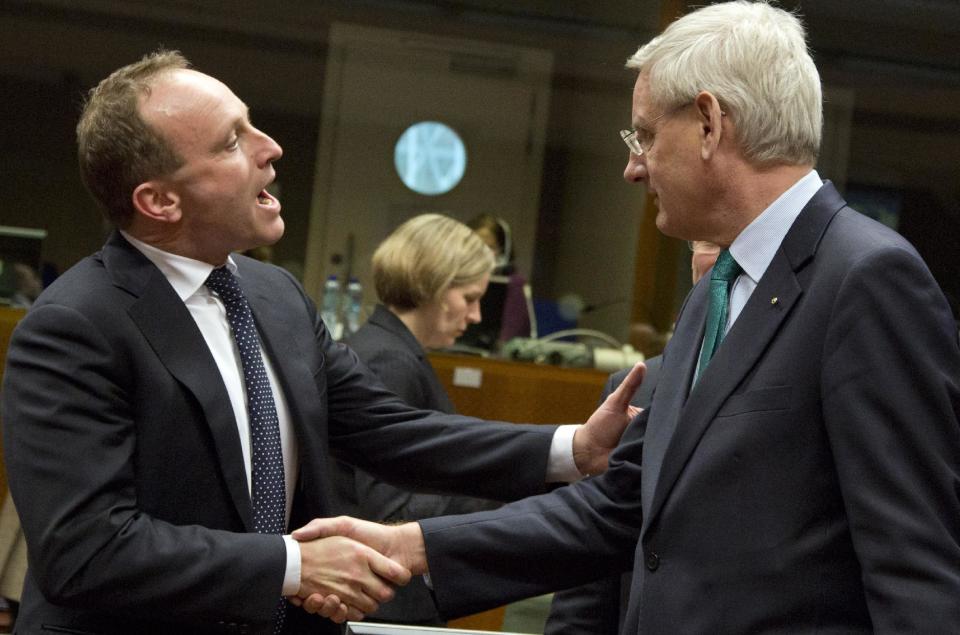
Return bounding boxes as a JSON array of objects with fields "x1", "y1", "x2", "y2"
[{"x1": 337, "y1": 214, "x2": 494, "y2": 625}]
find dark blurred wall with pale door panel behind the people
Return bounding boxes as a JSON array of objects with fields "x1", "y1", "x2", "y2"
[{"x1": 0, "y1": 0, "x2": 960, "y2": 340}]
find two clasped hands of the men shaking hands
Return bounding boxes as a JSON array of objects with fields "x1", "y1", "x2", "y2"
[{"x1": 287, "y1": 516, "x2": 427, "y2": 624}]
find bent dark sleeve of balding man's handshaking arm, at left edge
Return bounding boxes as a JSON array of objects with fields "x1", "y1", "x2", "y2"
[{"x1": 3, "y1": 304, "x2": 285, "y2": 623}]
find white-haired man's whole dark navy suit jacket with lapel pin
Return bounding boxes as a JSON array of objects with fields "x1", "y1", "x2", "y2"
[{"x1": 420, "y1": 183, "x2": 960, "y2": 634}]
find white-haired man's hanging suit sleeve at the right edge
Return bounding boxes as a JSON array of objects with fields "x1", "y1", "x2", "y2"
[{"x1": 822, "y1": 249, "x2": 960, "y2": 633}]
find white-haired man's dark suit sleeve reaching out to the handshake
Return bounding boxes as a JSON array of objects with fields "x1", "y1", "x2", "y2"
[{"x1": 420, "y1": 413, "x2": 646, "y2": 617}]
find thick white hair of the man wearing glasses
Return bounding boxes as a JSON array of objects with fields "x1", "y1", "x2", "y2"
[{"x1": 627, "y1": 0, "x2": 823, "y2": 165}]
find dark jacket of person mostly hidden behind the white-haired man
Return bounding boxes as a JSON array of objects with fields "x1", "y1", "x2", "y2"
[{"x1": 544, "y1": 355, "x2": 663, "y2": 635}]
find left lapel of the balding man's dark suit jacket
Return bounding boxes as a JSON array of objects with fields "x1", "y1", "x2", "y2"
[{"x1": 104, "y1": 234, "x2": 253, "y2": 531}]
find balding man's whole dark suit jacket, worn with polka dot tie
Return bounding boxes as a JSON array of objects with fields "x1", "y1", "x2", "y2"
[{"x1": 2, "y1": 234, "x2": 552, "y2": 635}]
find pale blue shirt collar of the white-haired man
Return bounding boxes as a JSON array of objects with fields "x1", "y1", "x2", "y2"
[{"x1": 730, "y1": 170, "x2": 823, "y2": 283}]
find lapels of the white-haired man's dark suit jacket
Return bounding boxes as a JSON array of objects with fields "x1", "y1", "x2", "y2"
[{"x1": 643, "y1": 182, "x2": 844, "y2": 530}]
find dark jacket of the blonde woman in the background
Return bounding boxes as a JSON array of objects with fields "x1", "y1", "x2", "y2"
[{"x1": 335, "y1": 305, "x2": 495, "y2": 625}]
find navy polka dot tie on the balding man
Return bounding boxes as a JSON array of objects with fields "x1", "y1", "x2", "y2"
[{"x1": 206, "y1": 267, "x2": 287, "y2": 633}]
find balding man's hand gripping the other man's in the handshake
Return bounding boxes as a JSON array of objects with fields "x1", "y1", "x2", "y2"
[{"x1": 291, "y1": 534, "x2": 410, "y2": 622}]
